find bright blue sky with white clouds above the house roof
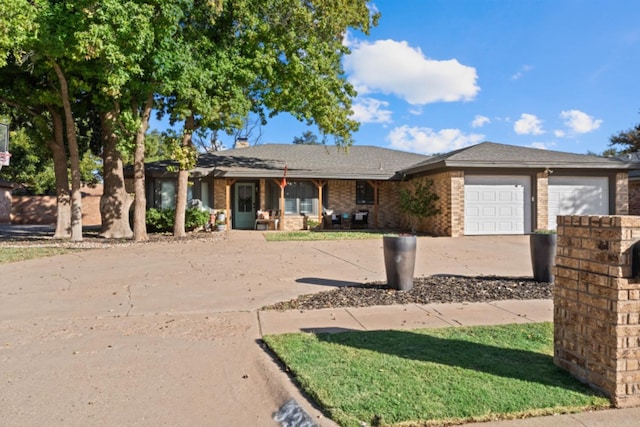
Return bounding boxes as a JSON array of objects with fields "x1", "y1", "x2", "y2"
[{"x1": 154, "y1": 0, "x2": 640, "y2": 154}]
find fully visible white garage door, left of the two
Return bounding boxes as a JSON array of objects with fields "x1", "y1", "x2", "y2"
[{"x1": 464, "y1": 175, "x2": 531, "y2": 235}]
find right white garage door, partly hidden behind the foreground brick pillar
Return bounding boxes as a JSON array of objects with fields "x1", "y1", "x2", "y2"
[{"x1": 549, "y1": 175, "x2": 609, "y2": 230}]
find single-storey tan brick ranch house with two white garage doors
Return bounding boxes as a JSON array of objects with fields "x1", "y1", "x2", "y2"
[{"x1": 125, "y1": 142, "x2": 638, "y2": 237}]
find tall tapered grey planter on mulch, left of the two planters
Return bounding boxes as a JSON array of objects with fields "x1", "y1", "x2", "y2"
[{"x1": 382, "y1": 236, "x2": 416, "y2": 291}]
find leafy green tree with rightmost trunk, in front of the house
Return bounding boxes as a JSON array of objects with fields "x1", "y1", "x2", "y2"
[{"x1": 163, "y1": 0, "x2": 378, "y2": 236}]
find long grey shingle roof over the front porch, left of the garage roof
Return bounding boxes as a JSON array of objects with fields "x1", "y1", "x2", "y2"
[{"x1": 195, "y1": 144, "x2": 428, "y2": 180}]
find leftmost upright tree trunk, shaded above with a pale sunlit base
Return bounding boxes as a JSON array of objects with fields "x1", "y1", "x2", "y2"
[{"x1": 48, "y1": 107, "x2": 71, "y2": 239}]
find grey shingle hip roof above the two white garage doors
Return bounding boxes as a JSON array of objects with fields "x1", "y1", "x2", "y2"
[{"x1": 402, "y1": 142, "x2": 635, "y2": 175}]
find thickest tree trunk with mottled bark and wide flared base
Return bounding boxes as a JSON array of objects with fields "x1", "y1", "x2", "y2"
[{"x1": 100, "y1": 112, "x2": 133, "y2": 239}]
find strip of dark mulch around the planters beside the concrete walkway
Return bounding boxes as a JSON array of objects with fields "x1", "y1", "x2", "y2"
[{"x1": 263, "y1": 275, "x2": 553, "y2": 310}]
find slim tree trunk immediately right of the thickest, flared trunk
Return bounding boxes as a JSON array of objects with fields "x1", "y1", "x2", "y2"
[{"x1": 133, "y1": 92, "x2": 153, "y2": 242}]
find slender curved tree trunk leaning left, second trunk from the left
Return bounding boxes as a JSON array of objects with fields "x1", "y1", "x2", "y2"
[{"x1": 52, "y1": 61, "x2": 82, "y2": 241}]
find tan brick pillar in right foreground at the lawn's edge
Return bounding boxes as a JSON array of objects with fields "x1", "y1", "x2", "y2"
[{"x1": 553, "y1": 216, "x2": 640, "y2": 407}]
